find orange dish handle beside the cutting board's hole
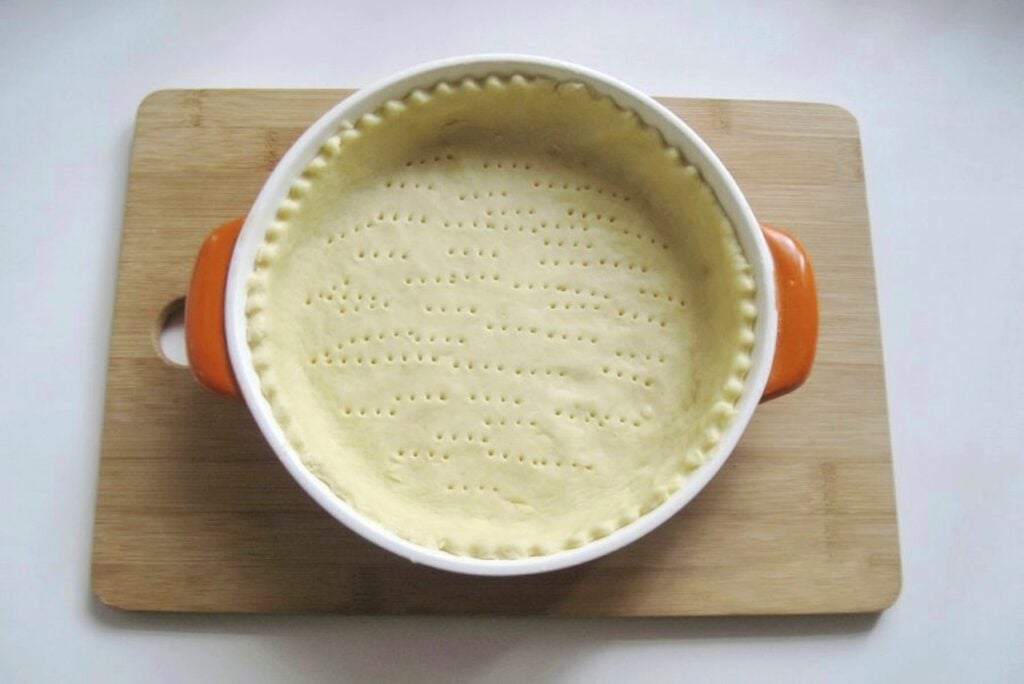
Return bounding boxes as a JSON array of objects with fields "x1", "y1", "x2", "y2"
[{"x1": 185, "y1": 216, "x2": 246, "y2": 399}]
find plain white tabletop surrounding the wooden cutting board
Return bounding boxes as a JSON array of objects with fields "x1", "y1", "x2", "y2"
[{"x1": 0, "y1": 0, "x2": 1024, "y2": 682}]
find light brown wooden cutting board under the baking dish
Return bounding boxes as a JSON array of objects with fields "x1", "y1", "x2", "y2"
[{"x1": 92, "y1": 90, "x2": 900, "y2": 615}]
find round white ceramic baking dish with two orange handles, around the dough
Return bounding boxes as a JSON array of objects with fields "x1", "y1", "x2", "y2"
[{"x1": 185, "y1": 55, "x2": 817, "y2": 575}]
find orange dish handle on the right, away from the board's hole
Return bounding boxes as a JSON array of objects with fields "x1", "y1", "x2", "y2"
[{"x1": 761, "y1": 225, "x2": 818, "y2": 401}]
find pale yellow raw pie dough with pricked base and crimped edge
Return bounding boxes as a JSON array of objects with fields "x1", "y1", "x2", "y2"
[{"x1": 247, "y1": 76, "x2": 756, "y2": 558}]
